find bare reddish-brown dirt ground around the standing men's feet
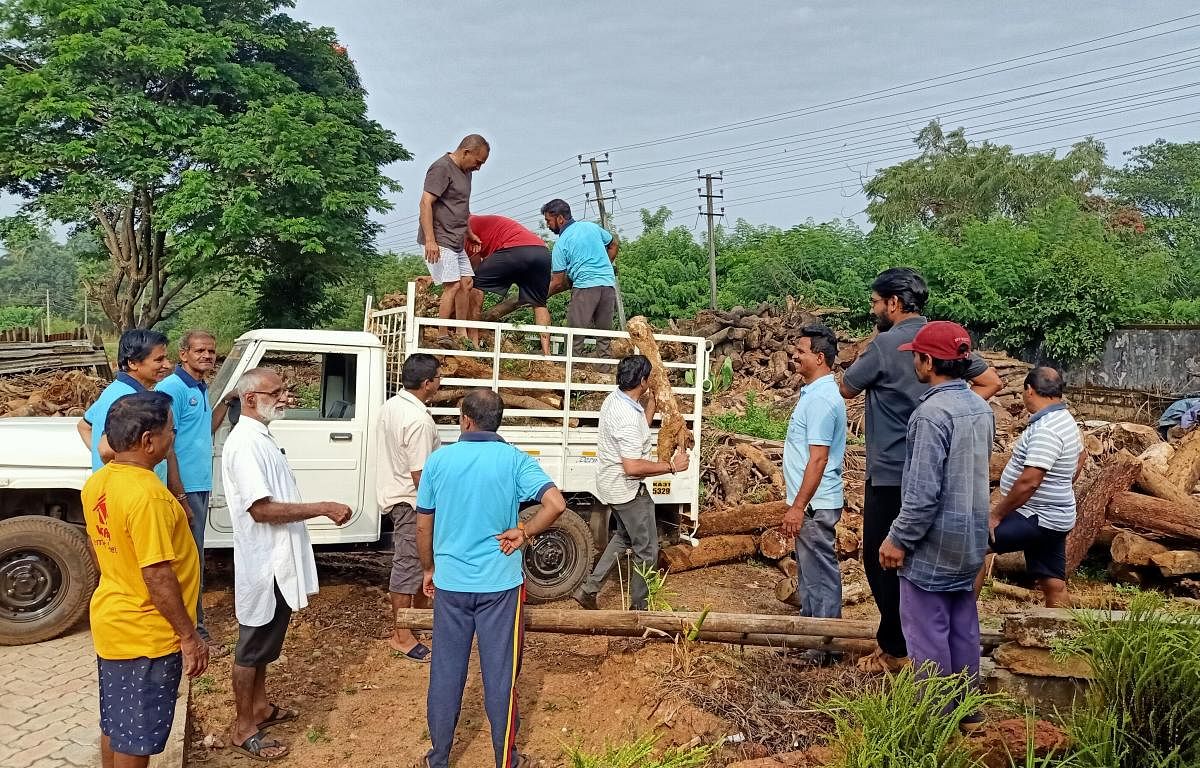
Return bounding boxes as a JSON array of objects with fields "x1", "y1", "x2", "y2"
[{"x1": 188, "y1": 552, "x2": 1113, "y2": 768}]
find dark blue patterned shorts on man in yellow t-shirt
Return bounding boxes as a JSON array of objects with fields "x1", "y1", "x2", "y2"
[{"x1": 96, "y1": 652, "x2": 184, "y2": 755}]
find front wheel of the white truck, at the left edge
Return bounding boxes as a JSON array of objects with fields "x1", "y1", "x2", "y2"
[{"x1": 0, "y1": 515, "x2": 98, "y2": 646}]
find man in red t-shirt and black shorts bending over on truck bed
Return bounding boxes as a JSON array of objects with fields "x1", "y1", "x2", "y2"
[{"x1": 468, "y1": 214, "x2": 550, "y2": 355}]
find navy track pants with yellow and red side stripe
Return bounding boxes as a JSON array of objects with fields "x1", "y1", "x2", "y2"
[{"x1": 426, "y1": 586, "x2": 524, "y2": 768}]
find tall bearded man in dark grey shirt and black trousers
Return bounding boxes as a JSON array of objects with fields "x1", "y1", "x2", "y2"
[{"x1": 841, "y1": 268, "x2": 1003, "y2": 671}]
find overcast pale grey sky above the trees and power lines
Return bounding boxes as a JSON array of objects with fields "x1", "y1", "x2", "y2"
[{"x1": 285, "y1": 0, "x2": 1200, "y2": 250}]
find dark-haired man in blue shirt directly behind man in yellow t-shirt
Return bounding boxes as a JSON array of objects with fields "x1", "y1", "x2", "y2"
[{"x1": 76, "y1": 328, "x2": 191, "y2": 501}]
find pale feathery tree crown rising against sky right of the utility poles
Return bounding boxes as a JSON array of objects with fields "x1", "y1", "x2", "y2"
[{"x1": 863, "y1": 120, "x2": 1105, "y2": 236}]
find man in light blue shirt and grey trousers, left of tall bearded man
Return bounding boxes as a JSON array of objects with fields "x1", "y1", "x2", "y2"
[{"x1": 780, "y1": 324, "x2": 846, "y2": 665}]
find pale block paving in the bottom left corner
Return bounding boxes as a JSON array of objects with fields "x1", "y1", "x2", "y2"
[{"x1": 0, "y1": 630, "x2": 100, "y2": 768}]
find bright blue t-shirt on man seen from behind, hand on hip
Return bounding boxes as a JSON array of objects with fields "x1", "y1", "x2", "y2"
[{"x1": 416, "y1": 432, "x2": 554, "y2": 592}]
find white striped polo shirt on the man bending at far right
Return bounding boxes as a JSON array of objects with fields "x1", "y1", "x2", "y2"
[{"x1": 1000, "y1": 403, "x2": 1084, "y2": 532}]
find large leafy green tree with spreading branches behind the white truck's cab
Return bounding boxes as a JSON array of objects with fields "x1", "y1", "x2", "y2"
[{"x1": 0, "y1": 0, "x2": 409, "y2": 329}]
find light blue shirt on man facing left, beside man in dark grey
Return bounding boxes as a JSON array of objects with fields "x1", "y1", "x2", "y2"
[{"x1": 784, "y1": 373, "x2": 846, "y2": 509}]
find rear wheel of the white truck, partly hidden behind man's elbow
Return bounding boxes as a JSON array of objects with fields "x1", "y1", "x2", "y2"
[{"x1": 521, "y1": 504, "x2": 595, "y2": 602}]
